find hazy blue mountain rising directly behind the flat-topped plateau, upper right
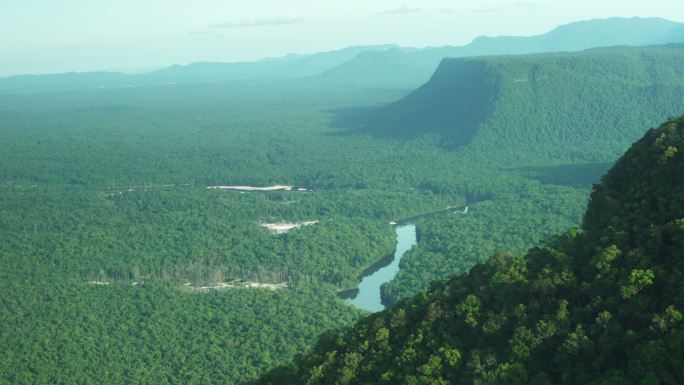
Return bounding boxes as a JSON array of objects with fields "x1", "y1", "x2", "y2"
[{"x1": 320, "y1": 18, "x2": 684, "y2": 87}]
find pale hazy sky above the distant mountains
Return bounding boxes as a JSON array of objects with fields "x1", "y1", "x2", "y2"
[{"x1": 0, "y1": 0, "x2": 684, "y2": 76}]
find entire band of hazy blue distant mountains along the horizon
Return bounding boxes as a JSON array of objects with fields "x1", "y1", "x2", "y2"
[{"x1": 0, "y1": 18, "x2": 684, "y2": 93}]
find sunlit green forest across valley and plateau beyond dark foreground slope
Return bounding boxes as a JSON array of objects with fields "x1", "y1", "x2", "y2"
[{"x1": 0, "y1": 42, "x2": 684, "y2": 384}]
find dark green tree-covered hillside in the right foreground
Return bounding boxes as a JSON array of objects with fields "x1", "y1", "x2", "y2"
[{"x1": 258, "y1": 117, "x2": 684, "y2": 385}]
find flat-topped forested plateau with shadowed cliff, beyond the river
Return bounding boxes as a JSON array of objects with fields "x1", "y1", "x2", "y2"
[{"x1": 338, "y1": 44, "x2": 684, "y2": 152}]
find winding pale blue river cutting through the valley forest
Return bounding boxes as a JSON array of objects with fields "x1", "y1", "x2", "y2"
[{"x1": 346, "y1": 223, "x2": 417, "y2": 312}]
